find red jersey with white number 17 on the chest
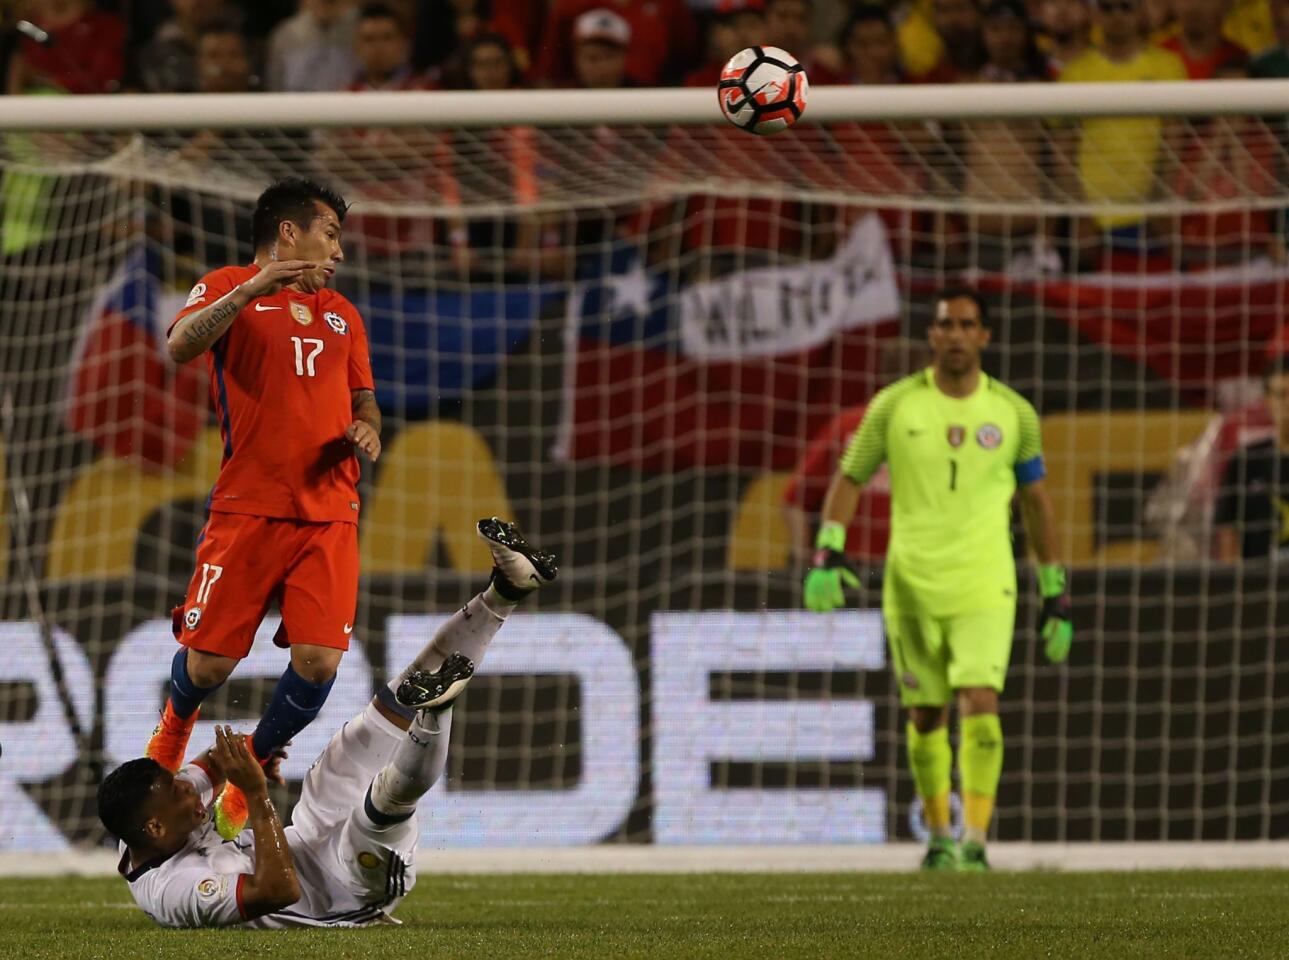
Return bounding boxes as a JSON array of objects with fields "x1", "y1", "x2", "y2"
[{"x1": 171, "y1": 265, "x2": 374, "y2": 523}]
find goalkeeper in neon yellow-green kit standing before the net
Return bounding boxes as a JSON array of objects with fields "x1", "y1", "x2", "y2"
[{"x1": 806, "y1": 290, "x2": 1072, "y2": 871}]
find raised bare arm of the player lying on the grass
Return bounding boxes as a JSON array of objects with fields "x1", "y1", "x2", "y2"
[{"x1": 210, "y1": 727, "x2": 300, "y2": 920}]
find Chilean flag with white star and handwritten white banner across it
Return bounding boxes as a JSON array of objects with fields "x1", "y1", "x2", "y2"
[{"x1": 554, "y1": 214, "x2": 900, "y2": 472}]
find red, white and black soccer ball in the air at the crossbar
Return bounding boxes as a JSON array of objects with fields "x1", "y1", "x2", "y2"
[{"x1": 717, "y1": 46, "x2": 809, "y2": 135}]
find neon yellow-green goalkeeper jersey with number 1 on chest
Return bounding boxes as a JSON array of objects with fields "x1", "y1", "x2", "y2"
[{"x1": 840, "y1": 367, "x2": 1044, "y2": 617}]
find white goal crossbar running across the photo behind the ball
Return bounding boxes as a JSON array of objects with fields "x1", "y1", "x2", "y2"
[{"x1": 0, "y1": 80, "x2": 1289, "y2": 130}]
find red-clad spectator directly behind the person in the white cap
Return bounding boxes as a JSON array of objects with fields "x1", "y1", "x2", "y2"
[{"x1": 538, "y1": 0, "x2": 700, "y2": 86}]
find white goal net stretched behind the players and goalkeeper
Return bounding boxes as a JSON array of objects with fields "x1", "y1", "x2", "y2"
[{"x1": 0, "y1": 81, "x2": 1289, "y2": 849}]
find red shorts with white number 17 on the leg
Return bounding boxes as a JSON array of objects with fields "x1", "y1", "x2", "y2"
[{"x1": 174, "y1": 512, "x2": 358, "y2": 660}]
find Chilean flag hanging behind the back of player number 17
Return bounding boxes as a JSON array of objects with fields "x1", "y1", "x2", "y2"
[{"x1": 63, "y1": 245, "x2": 209, "y2": 466}]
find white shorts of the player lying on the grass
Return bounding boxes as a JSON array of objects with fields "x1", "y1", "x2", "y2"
[{"x1": 285, "y1": 705, "x2": 420, "y2": 925}]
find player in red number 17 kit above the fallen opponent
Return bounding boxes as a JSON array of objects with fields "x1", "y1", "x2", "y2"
[{"x1": 147, "y1": 178, "x2": 380, "y2": 838}]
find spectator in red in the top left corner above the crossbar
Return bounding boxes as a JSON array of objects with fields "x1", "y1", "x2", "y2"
[{"x1": 5, "y1": 0, "x2": 125, "y2": 94}]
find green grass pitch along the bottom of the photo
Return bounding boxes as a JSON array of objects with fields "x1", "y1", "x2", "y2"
[{"x1": 0, "y1": 871, "x2": 1289, "y2": 960}]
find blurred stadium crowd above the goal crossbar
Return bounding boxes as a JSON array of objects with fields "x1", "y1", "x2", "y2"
[{"x1": 0, "y1": 0, "x2": 1289, "y2": 94}]
